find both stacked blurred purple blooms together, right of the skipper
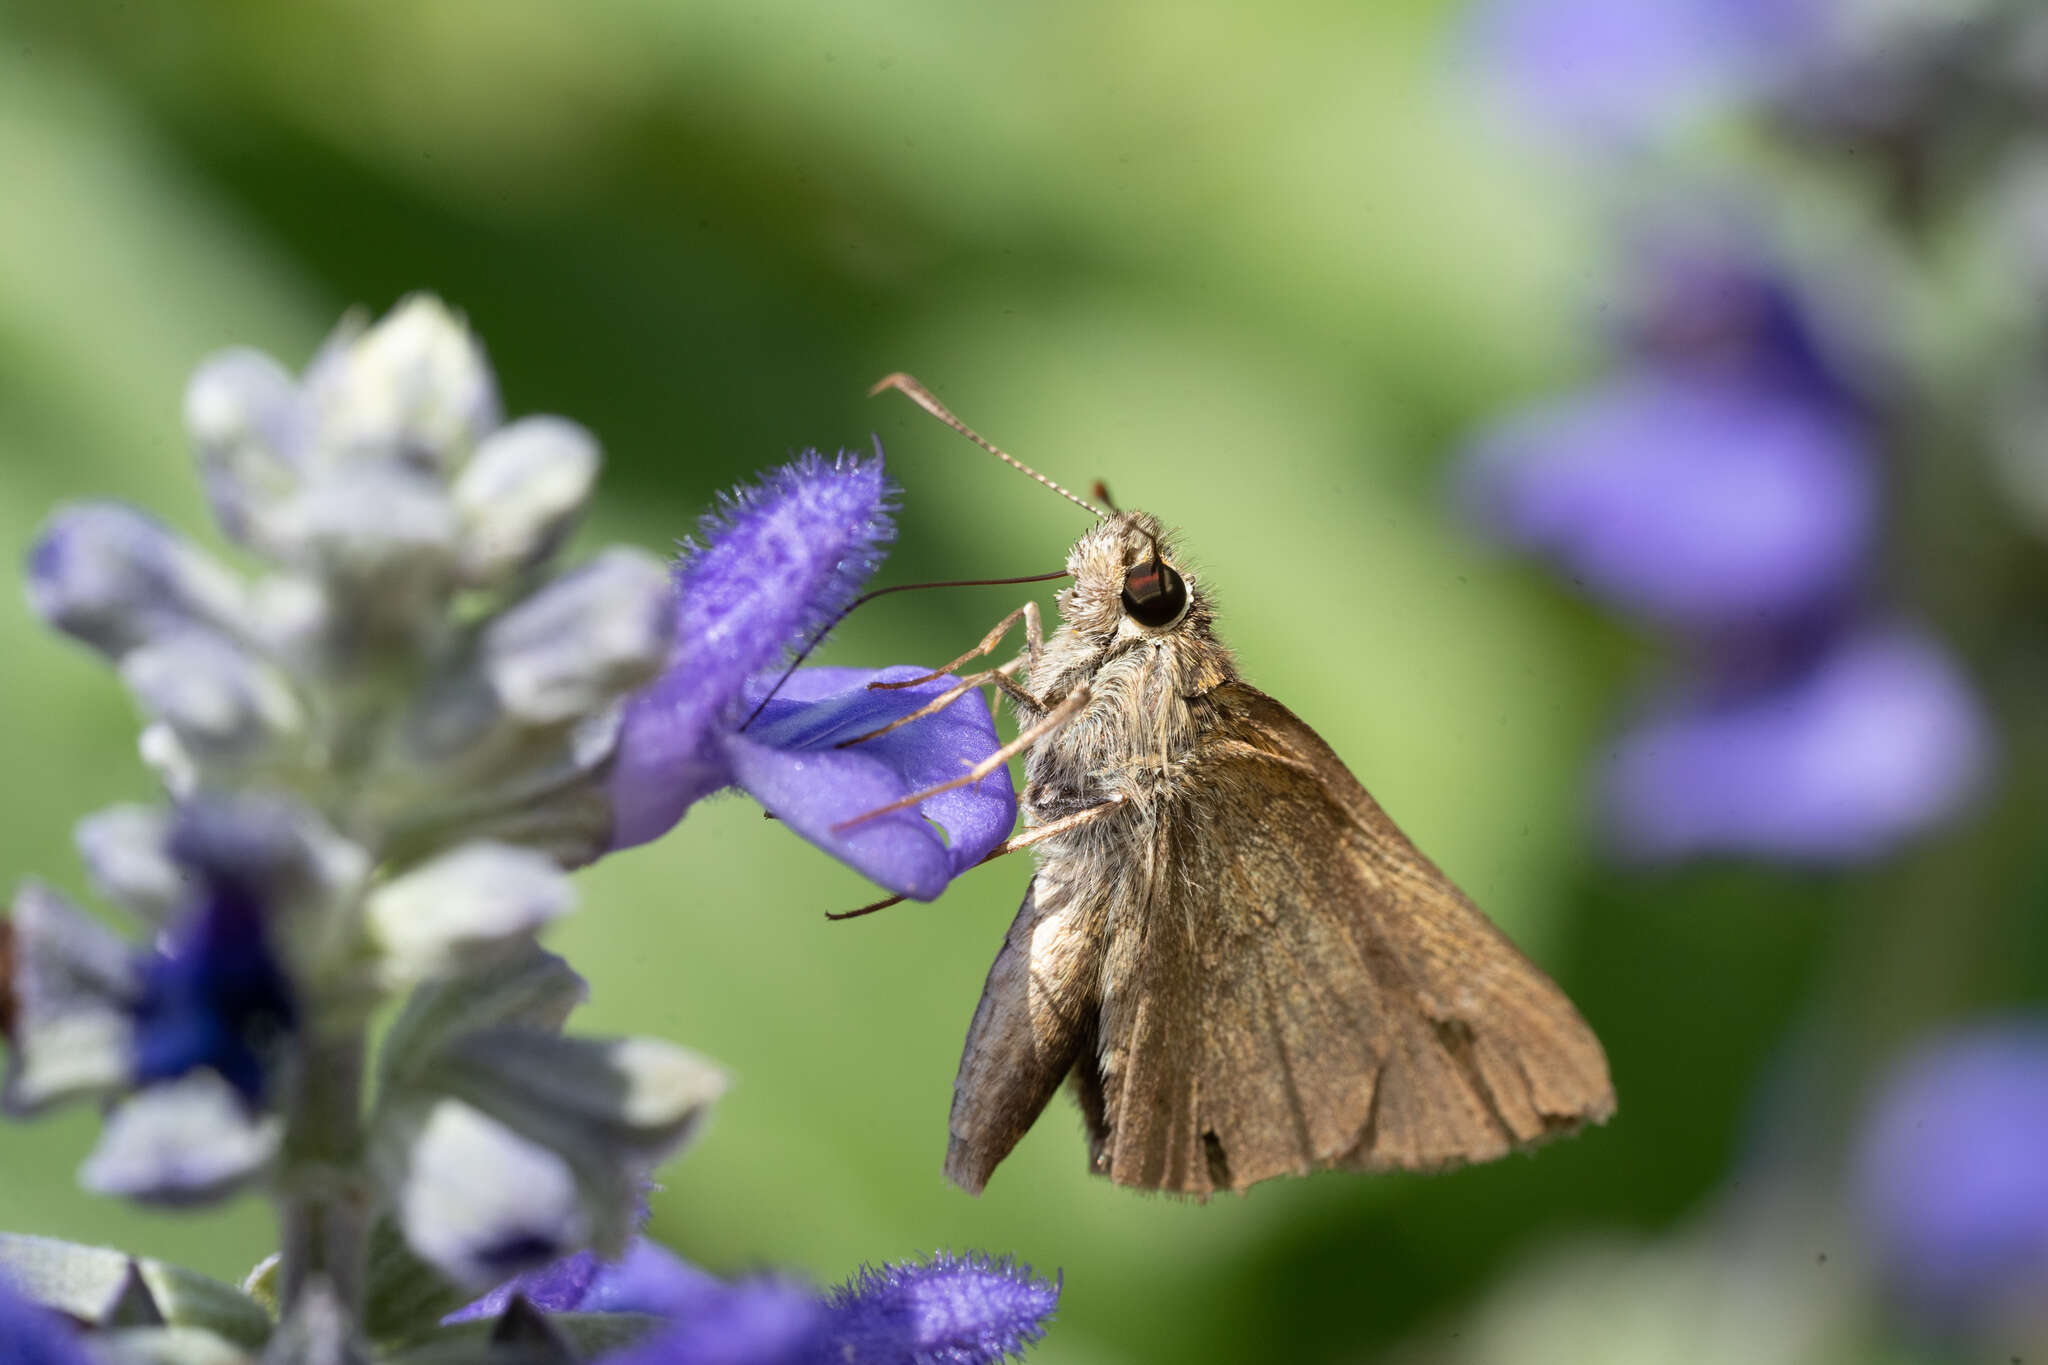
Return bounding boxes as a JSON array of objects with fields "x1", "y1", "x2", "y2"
[{"x1": 1462, "y1": 229, "x2": 1991, "y2": 862}]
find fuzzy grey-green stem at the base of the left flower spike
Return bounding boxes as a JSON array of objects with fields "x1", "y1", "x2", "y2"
[{"x1": 279, "y1": 1031, "x2": 375, "y2": 1322}]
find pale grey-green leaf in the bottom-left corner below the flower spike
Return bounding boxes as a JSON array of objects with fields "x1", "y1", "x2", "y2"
[{"x1": 0, "y1": 1232, "x2": 270, "y2": 1349}]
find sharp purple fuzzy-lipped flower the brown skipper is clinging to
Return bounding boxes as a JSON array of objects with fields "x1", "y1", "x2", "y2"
[{"x1": 610, "y1": 452, "x2": 1016, "y2": 900}]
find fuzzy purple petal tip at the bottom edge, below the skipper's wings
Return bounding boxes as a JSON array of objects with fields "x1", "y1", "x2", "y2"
[{"x1": 825, "y1": 1252, "x2": 1059, "y2": 1365}]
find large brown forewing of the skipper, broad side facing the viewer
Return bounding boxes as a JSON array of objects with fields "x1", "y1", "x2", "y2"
[{"x1": 1077, "y1": 684, "x2": 1614, "y2": 1195}]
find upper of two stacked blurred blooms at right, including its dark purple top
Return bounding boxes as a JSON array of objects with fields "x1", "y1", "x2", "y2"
[{"x1": 1464, "y1": 233, "x2": 1878, "y2": 630}]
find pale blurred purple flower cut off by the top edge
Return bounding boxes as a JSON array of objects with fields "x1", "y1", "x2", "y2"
[{"x1": 1464, "y1": 0, "x2": 1825, "y2": 149}]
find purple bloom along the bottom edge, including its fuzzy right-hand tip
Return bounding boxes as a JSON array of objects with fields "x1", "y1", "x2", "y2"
[{"x1": 462, "y1": 1240, "x2": 1059, "y2": 1365}]
